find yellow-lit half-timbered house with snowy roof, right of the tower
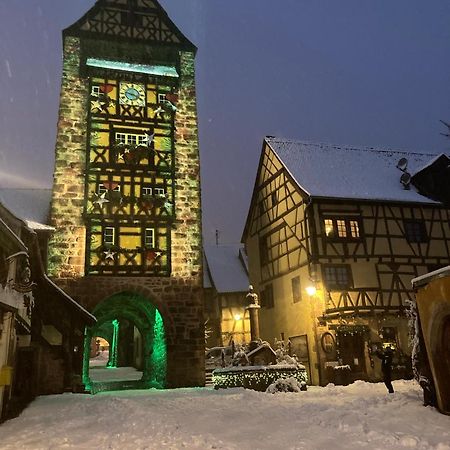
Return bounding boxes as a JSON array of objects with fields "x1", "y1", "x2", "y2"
[{"x1": 243, "y1": 137, "x2": 450, "y2": 384}]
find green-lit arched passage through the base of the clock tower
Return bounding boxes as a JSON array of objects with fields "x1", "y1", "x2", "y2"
[{"x1": 83, "y1": 292, "x2": 167, "y2": 391}]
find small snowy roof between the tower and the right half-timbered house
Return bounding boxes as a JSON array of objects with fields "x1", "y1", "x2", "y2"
[{"x1": 204, "y1": 244, "x2": 249, "y2": 293}]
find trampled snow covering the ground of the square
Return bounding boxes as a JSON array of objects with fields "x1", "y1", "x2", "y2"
[{"x1": 0, "y1": 381, "x2": 450, "y2": 450}]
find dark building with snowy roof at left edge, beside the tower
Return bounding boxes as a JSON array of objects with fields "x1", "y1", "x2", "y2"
[{"x1": 0, "y1": 189, "x2": 95, "y2": 421}]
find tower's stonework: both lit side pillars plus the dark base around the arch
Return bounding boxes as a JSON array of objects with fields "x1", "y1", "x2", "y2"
[{"x1": 49, "y1": 37, "x2": 205, "y2": 387}]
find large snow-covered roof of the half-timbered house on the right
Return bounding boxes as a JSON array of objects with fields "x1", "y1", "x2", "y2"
[{"x1": 266, "y1": 137, "x2": 439, "y2": 204}]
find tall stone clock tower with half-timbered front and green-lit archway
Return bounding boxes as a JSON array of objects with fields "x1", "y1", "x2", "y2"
[{"x1": 49, "y1": 0, "x2": 204, "y2": 387}]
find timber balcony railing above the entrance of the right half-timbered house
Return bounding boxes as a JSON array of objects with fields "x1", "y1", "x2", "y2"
[{"x1": 325, "y1": 288, "x2": 402, "y2": 314}]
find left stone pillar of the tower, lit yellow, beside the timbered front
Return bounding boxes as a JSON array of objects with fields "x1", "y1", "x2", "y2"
[{"x1": 48, "y1": 37, "x2": 88, "y2": 277}]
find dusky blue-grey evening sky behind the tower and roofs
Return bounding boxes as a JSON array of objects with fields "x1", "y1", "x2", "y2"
[{"x1": 0, "y1": 0, "x2": 450, "y2": 243}]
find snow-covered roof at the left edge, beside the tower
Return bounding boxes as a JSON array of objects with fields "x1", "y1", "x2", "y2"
[{"x1": 0, "y1": 188, "x2": 53, "y2": 231}]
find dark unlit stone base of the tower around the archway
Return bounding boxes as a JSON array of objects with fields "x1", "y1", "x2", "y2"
[{"x1": 57, "y1": 276, "x2": 205, "y2": 388}]
